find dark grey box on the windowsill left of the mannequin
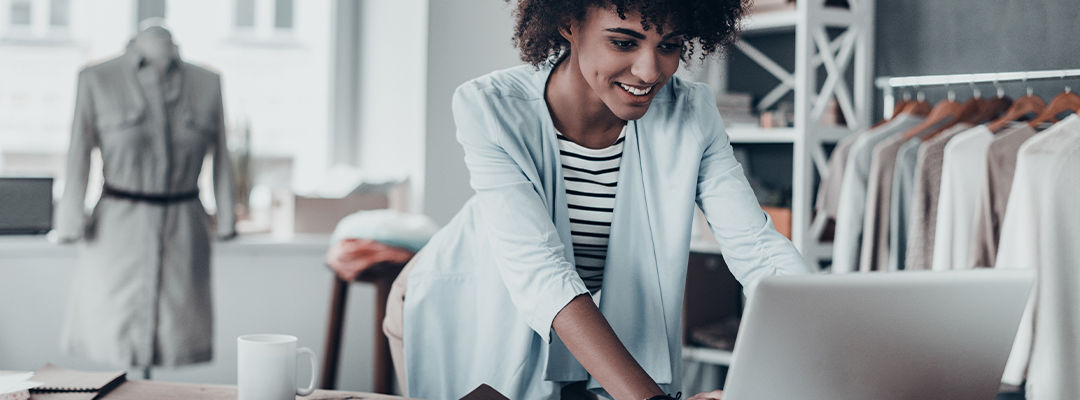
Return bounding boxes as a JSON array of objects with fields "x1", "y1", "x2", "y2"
[{"x1": 0, "y1": 176, "x2": 53, "y2": 235}]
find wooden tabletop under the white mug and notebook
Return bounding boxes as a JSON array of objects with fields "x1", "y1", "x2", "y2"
[{"x1": 70, "y1": 381, "x2": 405, "y2": 400}]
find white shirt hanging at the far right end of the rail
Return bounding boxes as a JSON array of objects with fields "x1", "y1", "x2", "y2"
[{"x1": 996, "y1": 116, "x2": 1080, "y2": 393}]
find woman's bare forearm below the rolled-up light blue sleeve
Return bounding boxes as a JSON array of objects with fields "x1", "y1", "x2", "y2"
[{"x1": 552, "y1": 294, "x2": 663, "y2": 400}]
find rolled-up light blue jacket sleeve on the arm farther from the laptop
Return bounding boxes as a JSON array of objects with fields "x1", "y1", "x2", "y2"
[{"x1": 453, "y1": 82, "x2": 589, "y2": 343}]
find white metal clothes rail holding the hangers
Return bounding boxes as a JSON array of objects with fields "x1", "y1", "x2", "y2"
[{"x1": 874, "y1": 69, "x2": 1080, "y2": 118}]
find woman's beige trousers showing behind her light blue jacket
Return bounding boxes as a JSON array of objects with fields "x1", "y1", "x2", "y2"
[{"x1": 382, "y1": 250, "x2": 597, "y2": 400}]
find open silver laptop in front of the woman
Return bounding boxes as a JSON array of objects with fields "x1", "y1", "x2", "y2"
[{"x1": 724, "y1": 270, "x2": 1035, "y2": 400}]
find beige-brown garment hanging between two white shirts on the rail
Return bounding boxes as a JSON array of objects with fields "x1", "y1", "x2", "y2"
[{"x1": 971, "y1": 123, "x2": 1035, "y2": 268}]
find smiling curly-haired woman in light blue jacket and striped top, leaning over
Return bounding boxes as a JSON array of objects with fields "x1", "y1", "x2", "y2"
[{"x1": 384, "y1": 0, "x2": 808, "y2": 399}]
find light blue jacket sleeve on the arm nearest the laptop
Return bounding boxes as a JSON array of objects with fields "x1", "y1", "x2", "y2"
[{"x1": 691, "y1": 85, "x2": 810, "y2": 297}]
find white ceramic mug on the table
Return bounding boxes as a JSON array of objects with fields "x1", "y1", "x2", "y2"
[{"x1": 237, "y1": 334, "x2": 319, "y2": 400}]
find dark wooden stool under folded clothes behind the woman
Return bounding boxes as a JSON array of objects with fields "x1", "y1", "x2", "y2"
[{"x1": 320, "y1": 259, "x2": 405, "y2": 394}]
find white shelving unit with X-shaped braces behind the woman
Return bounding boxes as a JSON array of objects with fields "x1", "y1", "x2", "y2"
[{"x1": 683, "y1": 0, "x2": 875, "y2": 384}]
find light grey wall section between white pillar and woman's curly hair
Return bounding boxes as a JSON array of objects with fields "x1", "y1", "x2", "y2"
[{"x1": 423, "y1": 0, "x2": 522, "y2": 224}]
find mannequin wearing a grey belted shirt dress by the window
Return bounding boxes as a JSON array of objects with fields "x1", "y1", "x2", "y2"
[{"x1": 56, "y1": 28, "x2": 235, "y2": 368}]
